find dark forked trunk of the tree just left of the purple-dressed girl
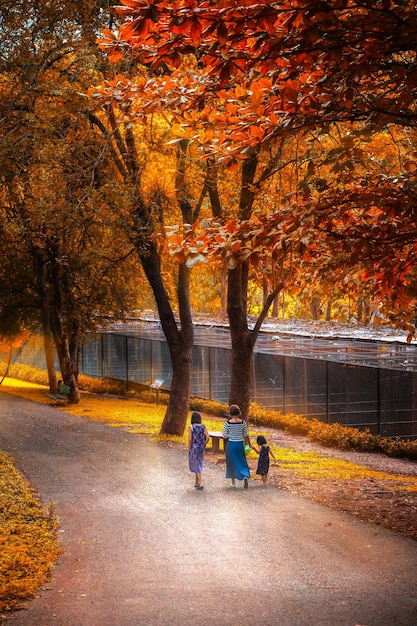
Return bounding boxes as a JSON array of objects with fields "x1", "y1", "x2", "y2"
[{"x1": 89, "y1": 105, "x2": 195, "y2": 436}]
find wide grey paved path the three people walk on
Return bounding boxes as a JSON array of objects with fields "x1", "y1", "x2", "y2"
[{"x1": 0, "y1": 393, "x2": 417, "y2": 626}]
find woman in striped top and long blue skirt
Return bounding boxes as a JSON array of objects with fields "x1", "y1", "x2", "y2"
[{"x1": 223, "y1": 404, "x2": 251, "y2": 489}]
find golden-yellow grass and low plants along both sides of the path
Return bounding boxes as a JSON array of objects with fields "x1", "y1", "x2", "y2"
[{"x1": 0, "y1": 372, "x2": 417, "y2": 610}]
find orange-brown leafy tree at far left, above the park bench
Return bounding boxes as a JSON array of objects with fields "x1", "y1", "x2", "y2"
[{"x1": 0, "y1": 2, "x2": 142, "y2": 401}]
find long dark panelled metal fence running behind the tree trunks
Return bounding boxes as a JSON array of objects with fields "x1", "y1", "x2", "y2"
[{"x1": 13, "y1": 324, "x2": 417, "y2": 438}]
